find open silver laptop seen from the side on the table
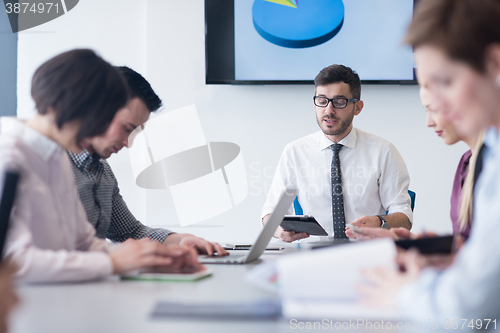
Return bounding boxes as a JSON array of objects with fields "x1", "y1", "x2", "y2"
[{"x1": 198, "y1": 189, "x2": 297, "y2": 264}]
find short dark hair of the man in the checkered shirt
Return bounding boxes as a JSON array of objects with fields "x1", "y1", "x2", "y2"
[{"x1": 116, "y1": 66, "x2": 162, "y2": 112}]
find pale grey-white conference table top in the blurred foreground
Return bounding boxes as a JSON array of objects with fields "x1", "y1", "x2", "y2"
[{"x1": 10, "y1": 251, "x2": 395, "y2": 333}]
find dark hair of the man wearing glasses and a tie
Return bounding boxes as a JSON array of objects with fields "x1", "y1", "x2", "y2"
[{"x1": 314, "y1": 65, "x2": 361, "y2": 99}]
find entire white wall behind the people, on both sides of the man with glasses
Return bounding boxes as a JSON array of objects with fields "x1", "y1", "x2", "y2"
[{"x1": 18, "y1": 0, "x2": 466, "y2": 242}]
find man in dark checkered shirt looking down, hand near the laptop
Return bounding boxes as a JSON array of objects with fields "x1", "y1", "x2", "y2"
[{"x1": 68, "y1": 67, "x2": 227, "y2": 255}]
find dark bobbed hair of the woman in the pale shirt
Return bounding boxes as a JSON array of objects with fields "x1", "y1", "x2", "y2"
[{"x1": 31, "y1": 49, "x2": 128, "y2": 143}]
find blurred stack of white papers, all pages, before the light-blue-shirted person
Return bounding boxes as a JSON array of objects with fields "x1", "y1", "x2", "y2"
[{"x1": 247, "y1": 239, "x2": 398, "y2": 319}]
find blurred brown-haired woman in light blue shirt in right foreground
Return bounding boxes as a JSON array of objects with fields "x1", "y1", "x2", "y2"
[{"x1": 360, "y1": 0, "x2": 500, "y2": 320}]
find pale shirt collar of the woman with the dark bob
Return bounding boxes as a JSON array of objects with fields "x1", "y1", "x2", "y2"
[{"x1": 0, "y1": 117, "x2": 63, "y2": 162}]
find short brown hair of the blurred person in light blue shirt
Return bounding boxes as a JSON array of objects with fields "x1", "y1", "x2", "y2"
[{"x1": 405, "y1": 0, "x2": 500, "y2": 72}]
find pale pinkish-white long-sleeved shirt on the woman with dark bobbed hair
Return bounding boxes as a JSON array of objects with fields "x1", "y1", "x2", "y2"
[{"x1": 0, "y1": 118, "x2": 113, "y2": 282}]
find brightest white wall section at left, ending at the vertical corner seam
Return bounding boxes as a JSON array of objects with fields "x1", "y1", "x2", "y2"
[{"x1": 17, "y1": 0, "x2": 147, "y2": 223}]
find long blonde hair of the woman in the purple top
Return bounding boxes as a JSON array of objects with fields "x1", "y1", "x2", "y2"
[{"x1": 458, "y1": 131, "x2": 484, "y2": 231}]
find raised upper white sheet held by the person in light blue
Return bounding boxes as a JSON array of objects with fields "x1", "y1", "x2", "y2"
[{"x1": 277, "y1": 239, "x2": 396, "y2": 302}]
